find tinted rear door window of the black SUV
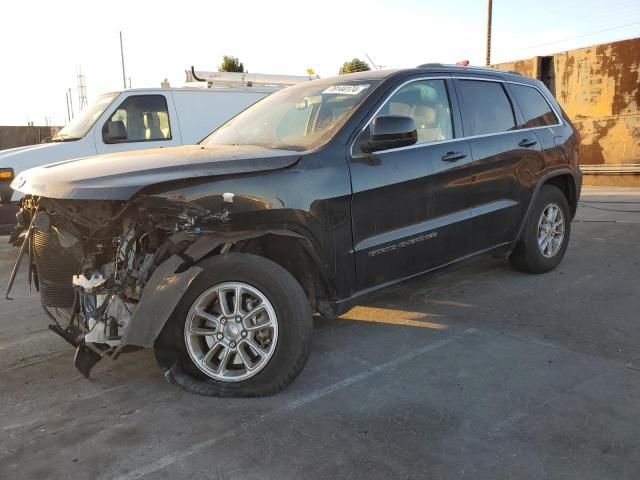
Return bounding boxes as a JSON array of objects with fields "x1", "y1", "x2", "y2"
[{"x1": 456, "y1": 80, "x2": 516, "y2": 137}]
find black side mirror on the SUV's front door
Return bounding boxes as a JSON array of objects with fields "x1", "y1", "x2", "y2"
[{"x1": 360, "y1": 115, "x2": 418, "y2": 153}]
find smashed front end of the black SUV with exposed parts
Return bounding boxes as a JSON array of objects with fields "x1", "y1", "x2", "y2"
[{"x1": 7, "y1": 195, "x2": 230, "y2": 377}]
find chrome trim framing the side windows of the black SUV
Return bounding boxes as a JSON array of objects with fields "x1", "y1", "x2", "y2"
[{"x1": 349, "y1": 76, "x2": 564, "y2": 159}]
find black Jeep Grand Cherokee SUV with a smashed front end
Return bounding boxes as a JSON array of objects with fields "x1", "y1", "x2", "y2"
[{"x1": 11, "y1": 64, "x2": 581, "y2": 396}]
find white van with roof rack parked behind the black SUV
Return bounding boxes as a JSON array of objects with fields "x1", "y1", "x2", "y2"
[{"x1": 0, "y1": 67, "x2": 314, "y2": 203}]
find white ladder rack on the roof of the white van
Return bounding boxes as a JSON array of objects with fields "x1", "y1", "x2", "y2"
[{"x1": 185, "y1": 67, "x2": 320, "y2": 88}]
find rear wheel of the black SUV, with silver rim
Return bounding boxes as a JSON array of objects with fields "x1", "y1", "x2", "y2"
[{"x1": 510, "y1": 185, "x2": 571, "y2": 273}]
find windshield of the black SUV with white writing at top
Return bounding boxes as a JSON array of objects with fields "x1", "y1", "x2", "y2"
[{"x1": 201, "y1": 79, "x2": 379, "y2": 151}]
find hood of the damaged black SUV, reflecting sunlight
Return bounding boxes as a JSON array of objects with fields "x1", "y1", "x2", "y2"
[{"x1": 11, "y1": 145, "x2": 300, "y2": 200}]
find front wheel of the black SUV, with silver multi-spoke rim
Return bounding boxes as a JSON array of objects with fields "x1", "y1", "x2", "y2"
[{"x1": 155, "y1": 253, "x2": 313, "y2": 397}]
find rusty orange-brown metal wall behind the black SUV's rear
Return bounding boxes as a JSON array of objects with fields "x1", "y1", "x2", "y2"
[{"x1": 496, "y1": 38, "x2": 640, "y2": 170}]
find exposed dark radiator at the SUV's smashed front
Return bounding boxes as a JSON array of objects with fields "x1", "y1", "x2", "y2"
[{"x1": 33, "y1": 228, "x2": 82, "y2": 308}]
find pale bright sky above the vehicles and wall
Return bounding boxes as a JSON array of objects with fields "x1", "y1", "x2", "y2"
[{"x1": 0, "y1": 0, "x2": 640, "y2": 125}]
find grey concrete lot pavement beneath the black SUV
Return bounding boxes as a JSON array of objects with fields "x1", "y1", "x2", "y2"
[{"x1": 0, "y1": 188, "x2": 640, "y2": 480}]
